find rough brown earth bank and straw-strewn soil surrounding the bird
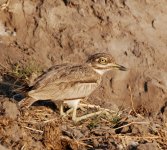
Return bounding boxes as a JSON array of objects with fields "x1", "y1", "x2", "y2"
[{"x1": 0, "y1": 0, "x2": 167, "y2": 150}]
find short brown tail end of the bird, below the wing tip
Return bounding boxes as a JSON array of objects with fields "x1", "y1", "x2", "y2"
[{"x1": 18, "y1": 97, "x2": 37, "y2": 108}]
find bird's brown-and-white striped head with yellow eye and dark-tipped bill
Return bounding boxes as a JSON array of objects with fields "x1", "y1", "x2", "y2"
[{"x1": 87, "y1": 53, "x2": 127, "y2": 75}]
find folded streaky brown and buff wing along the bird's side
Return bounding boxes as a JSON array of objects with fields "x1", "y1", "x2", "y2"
[{"x1": 29, "y1": 65, "x2": 100, "y2": 99}]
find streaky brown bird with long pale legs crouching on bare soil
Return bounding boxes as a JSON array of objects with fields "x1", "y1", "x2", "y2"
[{"x1": 19, "y1": 53, "x2": 127, "y2": 122}]
